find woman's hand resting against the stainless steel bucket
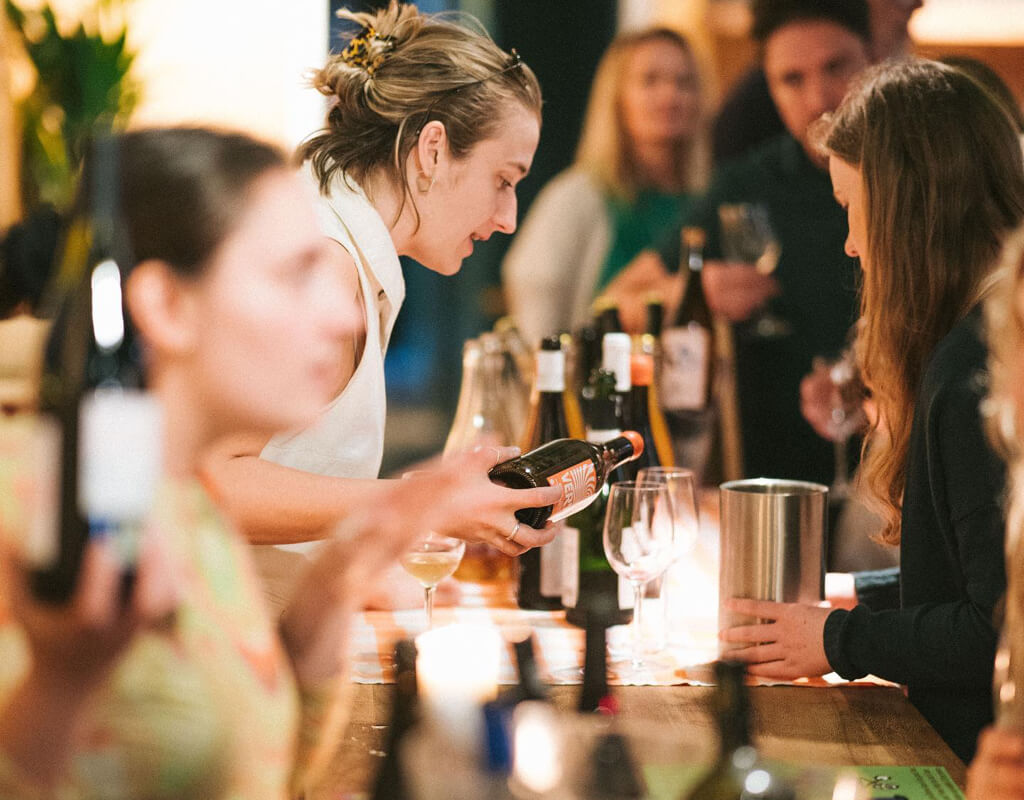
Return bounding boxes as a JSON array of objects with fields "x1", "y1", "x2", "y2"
[{"x1": 718, "y1": 597, "x2": 833, "y2": 680}]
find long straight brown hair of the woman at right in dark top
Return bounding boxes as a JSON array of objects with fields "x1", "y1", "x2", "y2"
[{"x1": 823, "y1": 60, "x2": 1024, "y2": 544}]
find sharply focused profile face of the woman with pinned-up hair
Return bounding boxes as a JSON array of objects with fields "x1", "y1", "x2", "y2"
[{"x1": 401, "y1": 102, "x2": 541, "y2": 275}]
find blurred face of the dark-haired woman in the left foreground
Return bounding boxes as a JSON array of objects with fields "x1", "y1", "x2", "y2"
[{"x1": 184, "y1": 169, "x2": 360, "y2": 432}]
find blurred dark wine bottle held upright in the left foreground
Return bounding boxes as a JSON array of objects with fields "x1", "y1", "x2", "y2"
[{"x1": 30, "y1": 137, "x2": 163, "y2": 603}]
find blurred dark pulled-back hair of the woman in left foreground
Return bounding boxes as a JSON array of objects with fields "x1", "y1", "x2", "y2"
[{"x1": 106, "y1": 128, "x2": 287, "y2": 276}]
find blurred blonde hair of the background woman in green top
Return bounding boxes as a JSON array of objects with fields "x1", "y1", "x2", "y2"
[{"x1": 575, "y1": 28, "x2": 710, "y2": 199}]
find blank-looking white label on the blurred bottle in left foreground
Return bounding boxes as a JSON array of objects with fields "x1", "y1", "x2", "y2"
[{"x1": 78, "y1": 389, "x2": 163, "y2": 525}]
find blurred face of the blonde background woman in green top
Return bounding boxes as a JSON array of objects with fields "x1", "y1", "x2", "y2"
[{"x1": 618, "y1": 39, "x2": 700, "y2": 146}]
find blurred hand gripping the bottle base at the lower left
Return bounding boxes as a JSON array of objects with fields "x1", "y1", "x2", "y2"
[{"x1": 0, "y1": 532, "x2": 181, "y2": 697}]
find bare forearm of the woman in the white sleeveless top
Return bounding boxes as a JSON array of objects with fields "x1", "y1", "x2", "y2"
[{"x1": 204, "y1": 456, "x2": 387, "y2": 544}]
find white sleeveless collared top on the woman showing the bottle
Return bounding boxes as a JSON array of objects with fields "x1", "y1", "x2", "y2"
[{"x1": 260, "y1": 165, "x2": 406, "y2": 551}]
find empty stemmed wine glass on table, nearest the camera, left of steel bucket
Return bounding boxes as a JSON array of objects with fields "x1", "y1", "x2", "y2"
[{"x1": 602, "y1": 480, "x2": 673, "y2": 680}]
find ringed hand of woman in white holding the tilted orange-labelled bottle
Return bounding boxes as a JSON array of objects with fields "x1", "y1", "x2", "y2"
[{"x1": 432, "y1": 447, "x2": 562, "y2": 555}]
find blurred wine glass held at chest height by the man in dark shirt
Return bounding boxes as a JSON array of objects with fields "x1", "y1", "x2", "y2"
[{"x1": 718, "y1": 203, "x2": 793, "y2": 339}]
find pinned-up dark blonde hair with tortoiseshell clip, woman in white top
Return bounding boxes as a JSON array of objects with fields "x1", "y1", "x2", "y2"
[{"x1": 298, "y1": 0, "x2": 541, "y2": 218}]
